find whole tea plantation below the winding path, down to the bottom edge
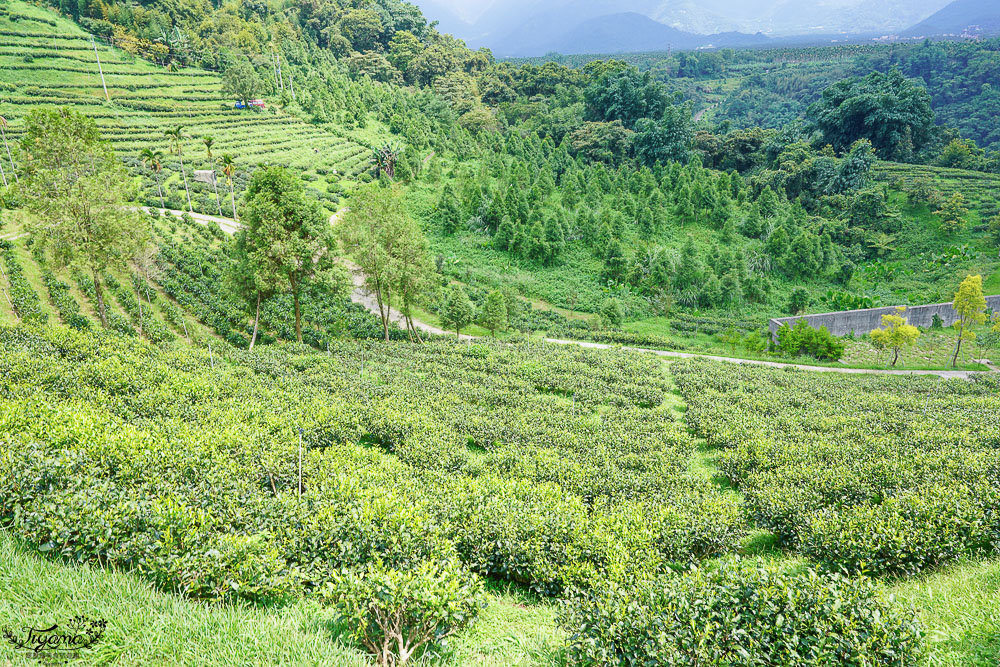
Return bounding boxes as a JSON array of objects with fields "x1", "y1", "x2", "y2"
[{"x1": 0, "y1": 197, "x2": 1000, "y2": 665}]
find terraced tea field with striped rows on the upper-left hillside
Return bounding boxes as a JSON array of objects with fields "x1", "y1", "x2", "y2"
[{"x1": 0, "y1": 2, "x2": 370, "y2": 213}]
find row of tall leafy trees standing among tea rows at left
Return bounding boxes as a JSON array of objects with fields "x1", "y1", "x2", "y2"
[{"x1": 5, "y1": 108, "x2": 434, "y2": 349}]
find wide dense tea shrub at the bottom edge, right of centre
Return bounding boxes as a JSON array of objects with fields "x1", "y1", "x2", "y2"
[{"x1": 561, "y1": 560, "x2": 921, "y2": 667}]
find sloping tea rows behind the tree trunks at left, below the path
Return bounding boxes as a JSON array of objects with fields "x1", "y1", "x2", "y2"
[{"x1": 0, "y1": 213, "x2": 394, "y2": 348}]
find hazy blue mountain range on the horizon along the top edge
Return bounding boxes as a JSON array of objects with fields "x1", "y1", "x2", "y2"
[{"x1": 415, "y1": 0, "x2": 960, "y2": 56}]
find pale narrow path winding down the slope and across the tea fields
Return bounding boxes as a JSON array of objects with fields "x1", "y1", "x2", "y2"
[{"x1": 142, "y1": 206, "x2": 996, "y2": 380}]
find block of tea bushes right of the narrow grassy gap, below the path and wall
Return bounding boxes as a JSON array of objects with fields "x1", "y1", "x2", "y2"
[{"x1": 674, "y1": 361, "x2": 1000, "y2": 576}]
